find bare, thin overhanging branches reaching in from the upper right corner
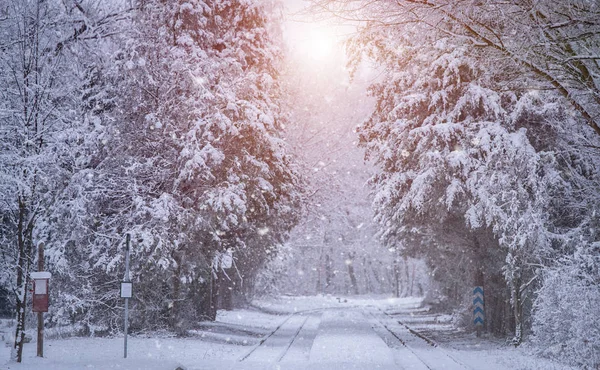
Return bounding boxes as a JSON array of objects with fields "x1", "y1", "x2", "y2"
[{"x1": 311, "y1": 0, "x2": 600, "y2": 133}]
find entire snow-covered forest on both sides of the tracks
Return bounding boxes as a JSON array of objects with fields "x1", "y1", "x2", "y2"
[{"x1": 0, "y1": 0, "x2": 600, "y2": 368}]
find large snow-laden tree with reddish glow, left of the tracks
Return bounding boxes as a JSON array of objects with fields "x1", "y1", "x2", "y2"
[{"x1": 46, "y1": 1, "x2": 301, "y2": 330}]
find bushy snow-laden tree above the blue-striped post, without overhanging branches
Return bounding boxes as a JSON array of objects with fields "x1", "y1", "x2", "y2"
[{"x1": 355, "y1": 23, "x2": 554, "y2": 340}]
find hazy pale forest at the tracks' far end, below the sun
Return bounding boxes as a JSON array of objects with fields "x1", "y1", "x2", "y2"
[{"x1": 259, "y1": 28, "x2": 428, "y2": 297}]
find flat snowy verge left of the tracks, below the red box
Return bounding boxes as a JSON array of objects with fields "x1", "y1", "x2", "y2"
[{"x1": 0, "y1": 309, "x2": 281, "y2": 370}]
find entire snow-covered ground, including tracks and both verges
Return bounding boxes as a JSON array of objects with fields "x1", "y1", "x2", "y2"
[{"x1": 0, "y1": 296, "x2": 569, "y2": 370}]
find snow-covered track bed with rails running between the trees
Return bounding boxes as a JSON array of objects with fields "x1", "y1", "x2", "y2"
[{"x1": 233, "y1": 307, "x2": 469, "y2": 370}]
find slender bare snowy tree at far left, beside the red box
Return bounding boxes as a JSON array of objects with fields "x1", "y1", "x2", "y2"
[{"x1": 0, "y1": 0, "x2": 132, "y2": 361}]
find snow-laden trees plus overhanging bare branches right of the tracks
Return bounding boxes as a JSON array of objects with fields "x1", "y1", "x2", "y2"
[{"x1": 313, "y1": 0, "x2": 600, "y2": 353}]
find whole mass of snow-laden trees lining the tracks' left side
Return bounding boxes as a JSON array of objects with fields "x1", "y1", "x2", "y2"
[{"x1": 0, "y1": 0, "x2": 301, "y2": 336}]
